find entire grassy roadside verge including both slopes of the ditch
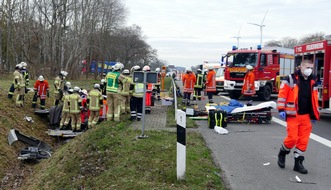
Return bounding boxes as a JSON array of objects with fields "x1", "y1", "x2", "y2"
[{"x1": 0, "y1": 76, "x2": 223, "y2": 190}]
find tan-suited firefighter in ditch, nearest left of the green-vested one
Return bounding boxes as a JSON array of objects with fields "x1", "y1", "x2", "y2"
[{"x1": 87, "y1": 83, "x2": 103, "y2": 129}]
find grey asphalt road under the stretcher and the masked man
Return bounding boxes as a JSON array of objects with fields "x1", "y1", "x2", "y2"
[{"x1": 175, "y1": 81, "x2": 331, "y2": 190}]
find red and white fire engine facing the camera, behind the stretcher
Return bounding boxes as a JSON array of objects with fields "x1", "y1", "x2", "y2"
[{"x1": 222, "y1": 46, "x2": 295, "y2": 100}]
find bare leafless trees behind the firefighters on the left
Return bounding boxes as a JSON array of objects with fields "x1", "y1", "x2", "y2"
[{"x1": 0, "y1": 0, "x2": 164, "y2": 77}]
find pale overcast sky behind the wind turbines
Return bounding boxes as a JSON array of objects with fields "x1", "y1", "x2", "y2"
[{"x1": 123, "y1": 0, "x2": 331, "y2": 68}]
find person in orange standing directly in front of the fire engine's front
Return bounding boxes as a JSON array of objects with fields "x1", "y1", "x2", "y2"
[{"x1": 241, "y1": 65, "x2": 256, "y2": 99}]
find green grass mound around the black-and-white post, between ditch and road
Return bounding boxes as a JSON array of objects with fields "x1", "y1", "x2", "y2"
[{"x1": 25, "y1": 123, "x2": 223, "y2": 189}]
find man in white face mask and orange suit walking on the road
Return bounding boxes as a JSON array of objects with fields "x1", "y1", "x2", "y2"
[{"x1": 277, "y1": 60, "x2": 320, "y2": 174}]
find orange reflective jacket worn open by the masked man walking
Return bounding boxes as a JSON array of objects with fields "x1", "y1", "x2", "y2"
[{"x1": 277, "y1": 74, "x2": 320, "y2": 120}]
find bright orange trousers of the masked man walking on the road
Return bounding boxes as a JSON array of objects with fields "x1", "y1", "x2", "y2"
[{"x1": 284, "y1": 114, "x2": 312, "y2": 152}]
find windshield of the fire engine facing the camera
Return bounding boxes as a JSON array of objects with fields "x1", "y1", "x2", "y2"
[{"x1": 227, "y1": 53, "x2": 257, "y2": 67}]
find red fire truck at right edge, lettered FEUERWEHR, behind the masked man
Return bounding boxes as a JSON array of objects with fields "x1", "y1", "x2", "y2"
[{"x1": 294, "y1": 37, "x2": 331, "y2": 111}]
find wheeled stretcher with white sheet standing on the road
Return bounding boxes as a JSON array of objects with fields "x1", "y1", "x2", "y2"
[{"x1": 205, "y1": 101, "x2": 276, "y2": 124}]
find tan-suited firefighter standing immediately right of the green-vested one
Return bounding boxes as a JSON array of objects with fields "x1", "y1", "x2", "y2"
[{"x1": 121, "y1": 69, "x2": 132, "y2": 113}]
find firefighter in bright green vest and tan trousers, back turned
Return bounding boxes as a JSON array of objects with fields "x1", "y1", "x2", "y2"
[{"x1": 106, "y1": 63, "x2": 126, "y2": 121}]
